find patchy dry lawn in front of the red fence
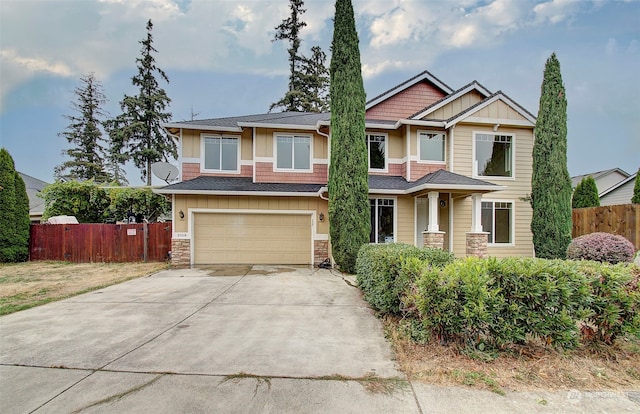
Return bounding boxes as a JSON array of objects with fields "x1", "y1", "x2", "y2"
[{"x1": 0, "y1": 262, "x2": 167, "y2": 315}]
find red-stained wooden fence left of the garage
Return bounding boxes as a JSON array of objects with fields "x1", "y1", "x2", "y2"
[{"x1": 29, "y1": 223, "x2": 171, "y2": 263}]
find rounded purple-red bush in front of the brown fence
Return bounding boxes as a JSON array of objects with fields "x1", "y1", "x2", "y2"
[{"x1": 567, "y1": 232, "x2": 635, "y2": 264}]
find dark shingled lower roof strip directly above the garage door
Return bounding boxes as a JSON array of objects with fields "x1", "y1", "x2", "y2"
[{"x1": 154, "y1": 176, "x2": 323, "y2": 196}]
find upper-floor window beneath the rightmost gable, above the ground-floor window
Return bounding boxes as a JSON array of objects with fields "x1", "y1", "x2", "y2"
[{"x1": 475, "y1": 134, "x2": 513, "y2": 177}]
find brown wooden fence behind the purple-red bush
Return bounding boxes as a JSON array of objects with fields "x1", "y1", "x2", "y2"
[{"x1": 572, "y1": 204, "x2": 640, "y2": 251}]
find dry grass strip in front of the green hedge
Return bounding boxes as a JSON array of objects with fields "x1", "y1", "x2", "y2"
[{"x1": 384, "y1": 318, "x2": 640, "y2": 394}]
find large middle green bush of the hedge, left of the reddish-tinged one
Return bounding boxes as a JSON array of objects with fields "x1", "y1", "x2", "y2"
[{"x1": 406, "y1": 258, "x2": 589, "y2": 348}]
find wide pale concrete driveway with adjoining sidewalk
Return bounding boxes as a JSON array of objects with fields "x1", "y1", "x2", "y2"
[{"x1": 0, "y1": 266, "x2": 640, "y2": 413}]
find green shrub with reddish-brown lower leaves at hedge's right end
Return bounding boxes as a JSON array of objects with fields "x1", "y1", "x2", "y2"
[{"x1": 580, "y1": 262, "x2": 640, "y2": 344}]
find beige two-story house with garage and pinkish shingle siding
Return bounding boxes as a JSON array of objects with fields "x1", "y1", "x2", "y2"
[{"x1": 156, "y1": 71, "x2": 535, "y2": 265}]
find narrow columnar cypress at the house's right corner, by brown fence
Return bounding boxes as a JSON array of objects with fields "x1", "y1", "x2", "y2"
[{"x1": 531, "y1": 53, "x2": 572, "y2": 259}]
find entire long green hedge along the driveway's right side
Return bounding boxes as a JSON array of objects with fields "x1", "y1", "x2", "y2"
[{"x1": 357, "y1": 244, "x2": 640, "y2": 349}]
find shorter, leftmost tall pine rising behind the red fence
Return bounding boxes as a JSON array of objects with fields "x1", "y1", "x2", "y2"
[{"x1": 55, "y1": 73, "x2": 110, "y2": 182}]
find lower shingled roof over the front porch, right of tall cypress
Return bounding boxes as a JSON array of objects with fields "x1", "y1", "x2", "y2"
[{"x1": 369, "y1": 170, "x2": 504, "y2": 194}]
